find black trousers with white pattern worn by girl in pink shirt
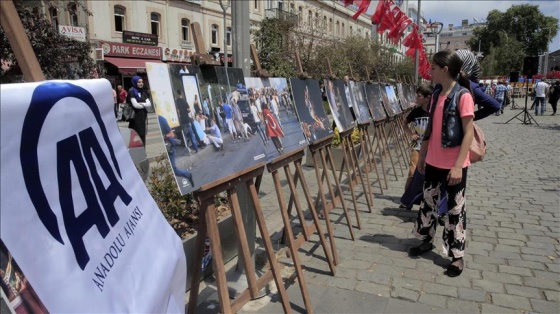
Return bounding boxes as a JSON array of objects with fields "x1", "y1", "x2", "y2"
[{"x1": 412, "y1": 164, "x2": 468, "y2": 258}]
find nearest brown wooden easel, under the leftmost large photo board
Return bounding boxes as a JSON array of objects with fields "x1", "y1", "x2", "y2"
[{"x1": 188, "y1": 163, "x2": 291, "y2": 314}]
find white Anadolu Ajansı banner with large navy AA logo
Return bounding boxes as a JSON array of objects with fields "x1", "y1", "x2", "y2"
[{"x1": 0, "y1": 80, "x2": 186, "y2": 313}]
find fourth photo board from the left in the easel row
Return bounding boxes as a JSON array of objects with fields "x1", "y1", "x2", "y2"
[{"x1": 324, "y1": 79, "x2": 355, "y2": 132}]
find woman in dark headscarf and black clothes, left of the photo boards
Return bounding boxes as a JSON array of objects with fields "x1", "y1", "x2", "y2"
[{"x1": 126, "y1": 76, "x2": 152, "y2": 145}]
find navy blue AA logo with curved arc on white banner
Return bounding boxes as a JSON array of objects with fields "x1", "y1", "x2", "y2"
[{"x1": 20, "y1": 82, "x2": 132, "y2": 270}]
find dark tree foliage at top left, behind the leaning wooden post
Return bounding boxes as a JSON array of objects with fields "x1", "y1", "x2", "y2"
[{"x1": 0, "y1": 0, "x2": 96, "y2": 82}]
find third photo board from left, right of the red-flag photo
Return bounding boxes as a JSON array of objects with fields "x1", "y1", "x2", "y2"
[{"x1": 290, "y1": 78, "x2": 334, "y2": 144}]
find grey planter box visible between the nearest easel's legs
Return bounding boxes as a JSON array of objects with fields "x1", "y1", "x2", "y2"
[{"x1": 183, "y1": 215, "x2": 238, "y2": 291}]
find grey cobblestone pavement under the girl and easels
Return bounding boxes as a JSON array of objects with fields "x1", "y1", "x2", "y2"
[{"x1": 237, "y1": 108, "x2": 560, "y2": 313}]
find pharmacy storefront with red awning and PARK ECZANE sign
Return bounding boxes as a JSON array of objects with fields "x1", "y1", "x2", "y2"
[{"x1": 99, "y1": 42, "x2": 162, "y2": 89}]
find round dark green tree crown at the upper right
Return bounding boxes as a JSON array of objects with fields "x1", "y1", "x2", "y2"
[{"x1": 468, "y1": 4, "x2": 558, "y2": 75}]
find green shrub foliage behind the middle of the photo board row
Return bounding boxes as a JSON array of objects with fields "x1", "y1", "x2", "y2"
[{"x1": 253, "y1": 10, "x2": 413, "y2": 80}]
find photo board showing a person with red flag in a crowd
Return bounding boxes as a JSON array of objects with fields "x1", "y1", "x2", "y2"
[{"x1": 245, "y1": 77, "x2": 307, "y2": 162}]
